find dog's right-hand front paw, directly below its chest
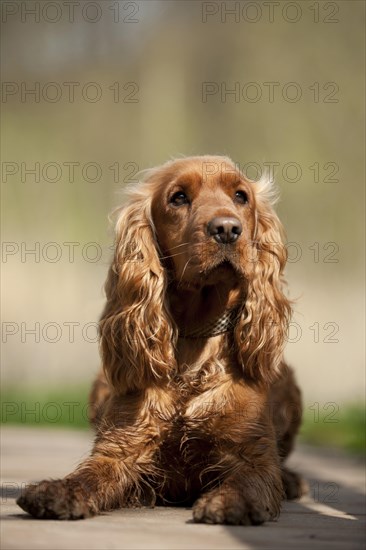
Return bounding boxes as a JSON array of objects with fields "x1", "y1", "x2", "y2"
[{"x1": 193, "y1": 488, "x2": 275, "y2": 525}]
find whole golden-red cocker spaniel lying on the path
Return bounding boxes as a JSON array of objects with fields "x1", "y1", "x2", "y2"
[{"x1": 18, "y1": 156, "x2": 302, "y2": 525}]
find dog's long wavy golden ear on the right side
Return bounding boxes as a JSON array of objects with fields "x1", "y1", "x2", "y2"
[{"x1": 235, "y1": 179, "x2": 291, "y2": 383}]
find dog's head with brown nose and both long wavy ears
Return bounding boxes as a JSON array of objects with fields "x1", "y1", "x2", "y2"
[{"x1": 101, "y1": 156, "x2": 290, "y2": 391}]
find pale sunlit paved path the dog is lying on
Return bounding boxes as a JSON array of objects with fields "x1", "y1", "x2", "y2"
[{"x1": 1, "y1": 427, "x2": 365, "y2": 550}]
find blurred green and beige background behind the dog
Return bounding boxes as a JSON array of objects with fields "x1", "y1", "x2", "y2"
[{"x1": 1, "y1": 0, "x2": 365, "y2": 448}]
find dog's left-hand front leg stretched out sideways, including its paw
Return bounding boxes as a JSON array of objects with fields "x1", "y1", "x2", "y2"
[{"x1": 17, "y1": 392, "x2": 163, "y2": 519}]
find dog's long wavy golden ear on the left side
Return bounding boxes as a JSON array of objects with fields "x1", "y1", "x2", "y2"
[{"x1": 100, "y1": 190, "x2": 176, "y2": 394}]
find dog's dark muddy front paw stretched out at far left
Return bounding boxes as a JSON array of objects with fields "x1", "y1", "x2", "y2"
[{"x1": 17, "y1": 478, "x2": 97, "y2": 520}]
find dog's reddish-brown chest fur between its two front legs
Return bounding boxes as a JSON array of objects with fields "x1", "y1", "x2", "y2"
[{"x1": 150, "y1": 361, "x2": 259, "y2": 504}]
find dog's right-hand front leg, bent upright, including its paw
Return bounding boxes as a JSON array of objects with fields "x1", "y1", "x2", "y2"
[{"x1": 191, "y1": 384, "x2": 284, "y2": 525}]
